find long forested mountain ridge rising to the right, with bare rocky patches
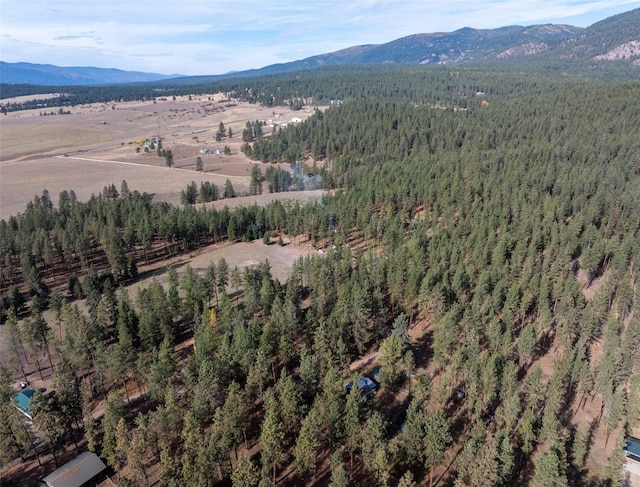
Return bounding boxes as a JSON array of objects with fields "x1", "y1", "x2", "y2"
[{"x1": 166, "y1": 9, "x2": 640, "y2": 84}]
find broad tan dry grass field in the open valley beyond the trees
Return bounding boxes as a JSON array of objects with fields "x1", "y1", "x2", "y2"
[{"x1": 0, "y1": 94, "x2": 320, "y2": 218}]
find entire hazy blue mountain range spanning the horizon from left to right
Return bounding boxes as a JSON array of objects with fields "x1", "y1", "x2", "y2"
[{"x1": 0, "y1": 9, "x2": 640, "y2": 86}]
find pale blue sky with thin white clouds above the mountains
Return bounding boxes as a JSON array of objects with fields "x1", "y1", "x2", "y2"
[{"x1": 0, "y1": 0, "x2": 640, "y2": 75}]
